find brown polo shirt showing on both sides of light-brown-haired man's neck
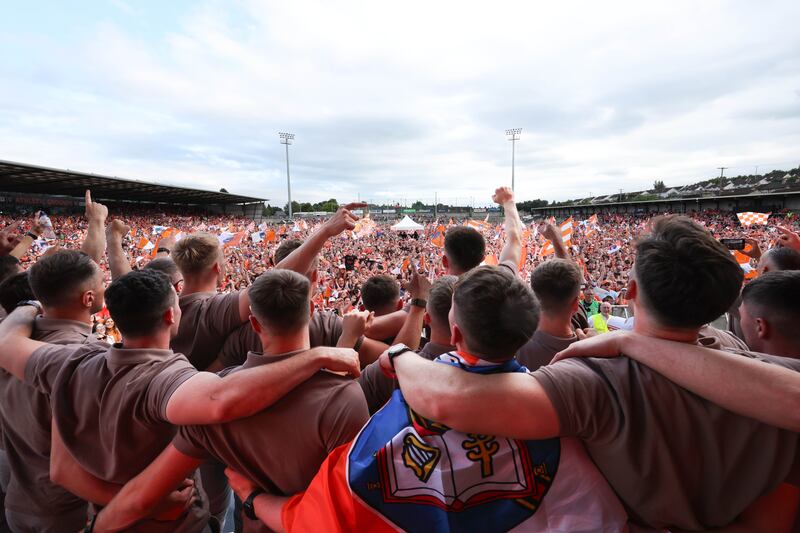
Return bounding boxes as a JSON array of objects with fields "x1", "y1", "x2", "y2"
[{"x1": 216, "y1": 311, "x2": 342, "y2": 368}]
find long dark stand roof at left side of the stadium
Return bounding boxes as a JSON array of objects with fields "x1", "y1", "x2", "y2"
[{"x1": 0, "y1": 160, "x2": 266, "y2": 205}]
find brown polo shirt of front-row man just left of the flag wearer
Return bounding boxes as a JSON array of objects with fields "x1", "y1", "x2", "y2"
[{"x1": 173, "y1": 352, "x2": 369, "y2": 532}]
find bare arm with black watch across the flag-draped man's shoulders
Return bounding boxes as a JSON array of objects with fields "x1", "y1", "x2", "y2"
[{"x1": 394, "y1": 352, "x2": 559, "y2": 439}]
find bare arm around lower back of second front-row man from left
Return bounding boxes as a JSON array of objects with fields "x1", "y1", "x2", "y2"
[{"x1": 50, "y1": 419, "x2": 122, "y2": 505}]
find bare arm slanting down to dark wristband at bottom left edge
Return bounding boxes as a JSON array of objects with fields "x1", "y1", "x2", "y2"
[{"x1": 94, "y1": 444, "x2": 202, "y2": 533}]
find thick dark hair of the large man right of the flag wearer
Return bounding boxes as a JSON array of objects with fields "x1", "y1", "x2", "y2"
[{"x1": 633, "y1": 215, "x2": 744, "y2": 329}]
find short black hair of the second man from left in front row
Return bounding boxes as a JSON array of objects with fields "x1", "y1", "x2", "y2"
[{"x1": 106, "y1": 268, "x2": 175, "y2": 337}]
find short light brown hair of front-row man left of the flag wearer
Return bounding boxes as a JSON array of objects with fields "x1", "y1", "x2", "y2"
[{"x1": 247, "y1": 268, "x2": 311, "y2": 333}]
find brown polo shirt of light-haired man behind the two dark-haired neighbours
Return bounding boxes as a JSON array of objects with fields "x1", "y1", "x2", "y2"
[{"x1": 170, "y1": 292, "x2": 241, "y2": 370}]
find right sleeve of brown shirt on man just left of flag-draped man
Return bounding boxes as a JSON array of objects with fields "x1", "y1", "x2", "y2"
[{"x1": 320, "y1": 378, "x2": 369, "y2": 453}]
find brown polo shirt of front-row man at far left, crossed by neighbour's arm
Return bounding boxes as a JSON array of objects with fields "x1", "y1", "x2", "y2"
[{"x1": 0, "y1": 317, "x2": 94, "y2": 516}]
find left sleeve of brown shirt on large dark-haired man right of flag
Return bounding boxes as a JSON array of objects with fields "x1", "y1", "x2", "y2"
[{"x1": 531, "y1": 358, "x2": 628, "y2": 442}]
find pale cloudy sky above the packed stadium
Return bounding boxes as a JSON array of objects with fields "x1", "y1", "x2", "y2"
[{"x1": 0, "y1": 0, "x2": 800, "y2": 205}]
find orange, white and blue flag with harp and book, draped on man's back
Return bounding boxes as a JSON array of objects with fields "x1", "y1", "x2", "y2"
[{"x1": 281, "y1": 352, "x2": 627, "y2": 533}]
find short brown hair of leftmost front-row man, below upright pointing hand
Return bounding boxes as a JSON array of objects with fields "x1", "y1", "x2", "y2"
[{"x1": 28, "y1": 250, "x2": 99, "y2": 307}]
